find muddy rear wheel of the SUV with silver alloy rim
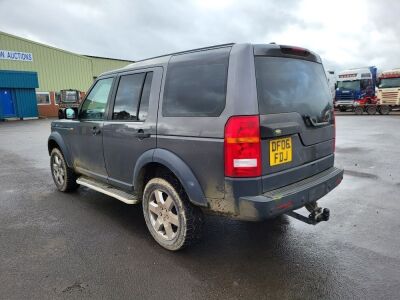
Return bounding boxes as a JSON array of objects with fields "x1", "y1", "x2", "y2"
[{"x1": 143, "y1": 176, "x2": 203, "y2": 251}]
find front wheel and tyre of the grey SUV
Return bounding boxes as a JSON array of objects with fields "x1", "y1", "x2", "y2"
[{"x1": 50, "y1": 148, "x2": 79, "y2": 193}]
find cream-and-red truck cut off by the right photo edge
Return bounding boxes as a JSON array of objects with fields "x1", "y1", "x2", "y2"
[{"x1": 377, "y1": 68, "x2": 400, "y2": 115}]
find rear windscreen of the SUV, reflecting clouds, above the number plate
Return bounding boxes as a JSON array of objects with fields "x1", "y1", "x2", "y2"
[{"x1": 255, "y1": 56, "x2": 333, "y2": 122}]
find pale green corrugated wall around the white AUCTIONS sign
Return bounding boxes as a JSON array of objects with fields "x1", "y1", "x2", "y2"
[{"x1": 0, "y1": 32, "x2": 131, "y2": 92}]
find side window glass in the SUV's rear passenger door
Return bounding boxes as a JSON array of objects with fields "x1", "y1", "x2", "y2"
[{"x1": 113, "y1": 72, "x2": 153, "y2": 121}]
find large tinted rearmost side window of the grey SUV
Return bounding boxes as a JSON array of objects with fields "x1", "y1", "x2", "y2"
[{"x1": 163, "y1": 48, "x2": 230, "y2": 117}]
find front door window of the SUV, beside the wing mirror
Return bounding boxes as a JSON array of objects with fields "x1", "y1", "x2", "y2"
[{"x1": 79, "y1": 78, "x2": 113, "y2": 120}]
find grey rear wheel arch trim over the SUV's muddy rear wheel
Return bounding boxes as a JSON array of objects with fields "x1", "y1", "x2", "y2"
[{"x1": 133, "y1": 149, "x2": 207, "y2": 207}]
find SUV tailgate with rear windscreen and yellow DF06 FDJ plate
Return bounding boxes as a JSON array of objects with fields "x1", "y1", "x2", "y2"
[{"x1": 254, "y1": 45, "x2": 335, "y2": 192}]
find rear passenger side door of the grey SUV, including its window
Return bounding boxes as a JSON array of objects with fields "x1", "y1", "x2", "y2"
[{"x1": 103, "y1": 67, "x2": 163, "y2": 190}]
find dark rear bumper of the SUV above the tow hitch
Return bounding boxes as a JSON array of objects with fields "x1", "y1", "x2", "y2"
[{"x1": 227, "y1": 167, "x2": 343, "y2": 221}]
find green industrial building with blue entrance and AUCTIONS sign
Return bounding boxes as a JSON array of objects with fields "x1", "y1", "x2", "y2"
[{"x1": 0, "y1": 31, "x2": 132, "y2": 120}]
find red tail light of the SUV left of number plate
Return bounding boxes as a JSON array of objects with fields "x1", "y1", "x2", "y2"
[{"x1": 224, "y1": 116, "x2": 261, "y2": 177}]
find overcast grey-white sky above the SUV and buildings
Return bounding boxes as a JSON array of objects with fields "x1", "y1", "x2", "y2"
[{"x1": 0, "y1": 0, "x2": 400, "y2": 71}]
